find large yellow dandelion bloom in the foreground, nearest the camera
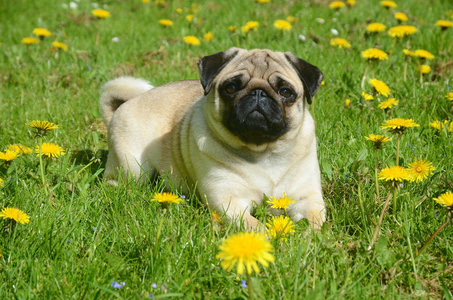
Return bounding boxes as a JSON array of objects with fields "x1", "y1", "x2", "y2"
[{"x1": 216, "y1": 232, "x2": 275, "y2": 275}]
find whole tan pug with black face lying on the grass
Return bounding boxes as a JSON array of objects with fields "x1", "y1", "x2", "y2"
[{"x1": 100, "y1": 48, "x2": 326, "y2": 230}]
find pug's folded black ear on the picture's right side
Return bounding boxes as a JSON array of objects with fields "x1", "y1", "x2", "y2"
[{"x1": 285, "y1": 52, "x2": 324, "y2": 104}]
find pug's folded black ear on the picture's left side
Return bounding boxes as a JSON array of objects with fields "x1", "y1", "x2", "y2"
[{"x1": 198, "y1": 48, "x2": 239, "y2": 95}]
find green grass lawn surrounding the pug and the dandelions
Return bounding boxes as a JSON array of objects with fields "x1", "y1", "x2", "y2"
[{"x1": 0, "y1": 0, "x2": 453, "y2": 299}]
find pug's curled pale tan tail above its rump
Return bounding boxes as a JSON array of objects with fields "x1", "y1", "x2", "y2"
[{"x1": 99, "y1": 77, "x2": 153, "y2": 126}]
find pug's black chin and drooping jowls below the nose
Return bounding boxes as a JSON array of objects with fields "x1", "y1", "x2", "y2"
[{"x1": 225, "y1": 110, "x2": 288, "y2": 145}]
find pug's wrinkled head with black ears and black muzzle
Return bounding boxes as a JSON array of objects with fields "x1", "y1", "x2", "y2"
[{"x1": 199, "y1": 48, "x2": 323, "y2": 145}]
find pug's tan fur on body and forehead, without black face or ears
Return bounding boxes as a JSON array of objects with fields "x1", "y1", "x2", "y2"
[{"x1": 102, "y1": 49, "x2": 325, "y2": 230}]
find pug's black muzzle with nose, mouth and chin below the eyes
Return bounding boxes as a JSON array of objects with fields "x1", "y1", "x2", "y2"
[{"x1": 225, "y1": 90, "x2": 287, "y2": 145}]
